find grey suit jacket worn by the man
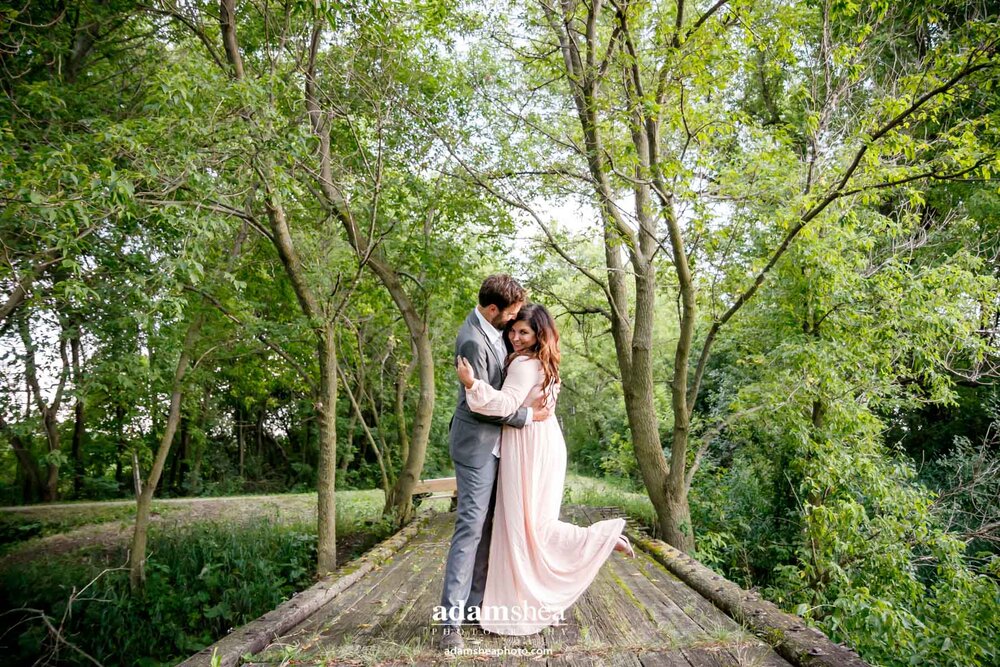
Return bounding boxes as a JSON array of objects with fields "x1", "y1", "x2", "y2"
[{"x1": 448, "y1": 311, "x2": 528, "y2": 468}]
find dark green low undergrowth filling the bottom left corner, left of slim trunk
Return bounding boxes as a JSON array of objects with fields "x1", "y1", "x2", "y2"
[{"x1": 0, "y1": 518, "x2": 316, "y2": 665}]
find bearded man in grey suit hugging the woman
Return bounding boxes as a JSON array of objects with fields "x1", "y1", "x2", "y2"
[{"x1": 440, "y1": 275, "x2": 549, "y2": 651}]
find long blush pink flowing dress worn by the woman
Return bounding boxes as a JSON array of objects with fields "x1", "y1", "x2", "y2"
[{"x1": 466, "y1": 356, "x2": 625, "y2": 635}]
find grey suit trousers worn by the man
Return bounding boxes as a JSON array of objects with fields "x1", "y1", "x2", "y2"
[{"x1": 441, "y1": 455, "x2": 500, "y2": 625}]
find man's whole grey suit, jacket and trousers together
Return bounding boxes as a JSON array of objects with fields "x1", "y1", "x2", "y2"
[{"x1": 441, "y1": 311, "x2": 528, "y2": 628}]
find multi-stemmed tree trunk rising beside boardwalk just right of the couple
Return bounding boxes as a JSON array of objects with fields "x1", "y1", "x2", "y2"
[{"x1": 542, "y1": 2, "x2": 695, "y2": 551}]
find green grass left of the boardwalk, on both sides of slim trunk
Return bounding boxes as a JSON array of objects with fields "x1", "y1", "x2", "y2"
[{"x1": 0, "y1": 490, "x2": 390, "y2": 665}]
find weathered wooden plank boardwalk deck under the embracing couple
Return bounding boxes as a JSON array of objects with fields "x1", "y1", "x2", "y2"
[{"x1": 238, "y1": 507, "x2": 790, "y2": 667}]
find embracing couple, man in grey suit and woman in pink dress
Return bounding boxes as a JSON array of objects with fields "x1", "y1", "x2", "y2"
[{"x1": 435, "y1": 275, "x2": 632, "y2": 650}]
